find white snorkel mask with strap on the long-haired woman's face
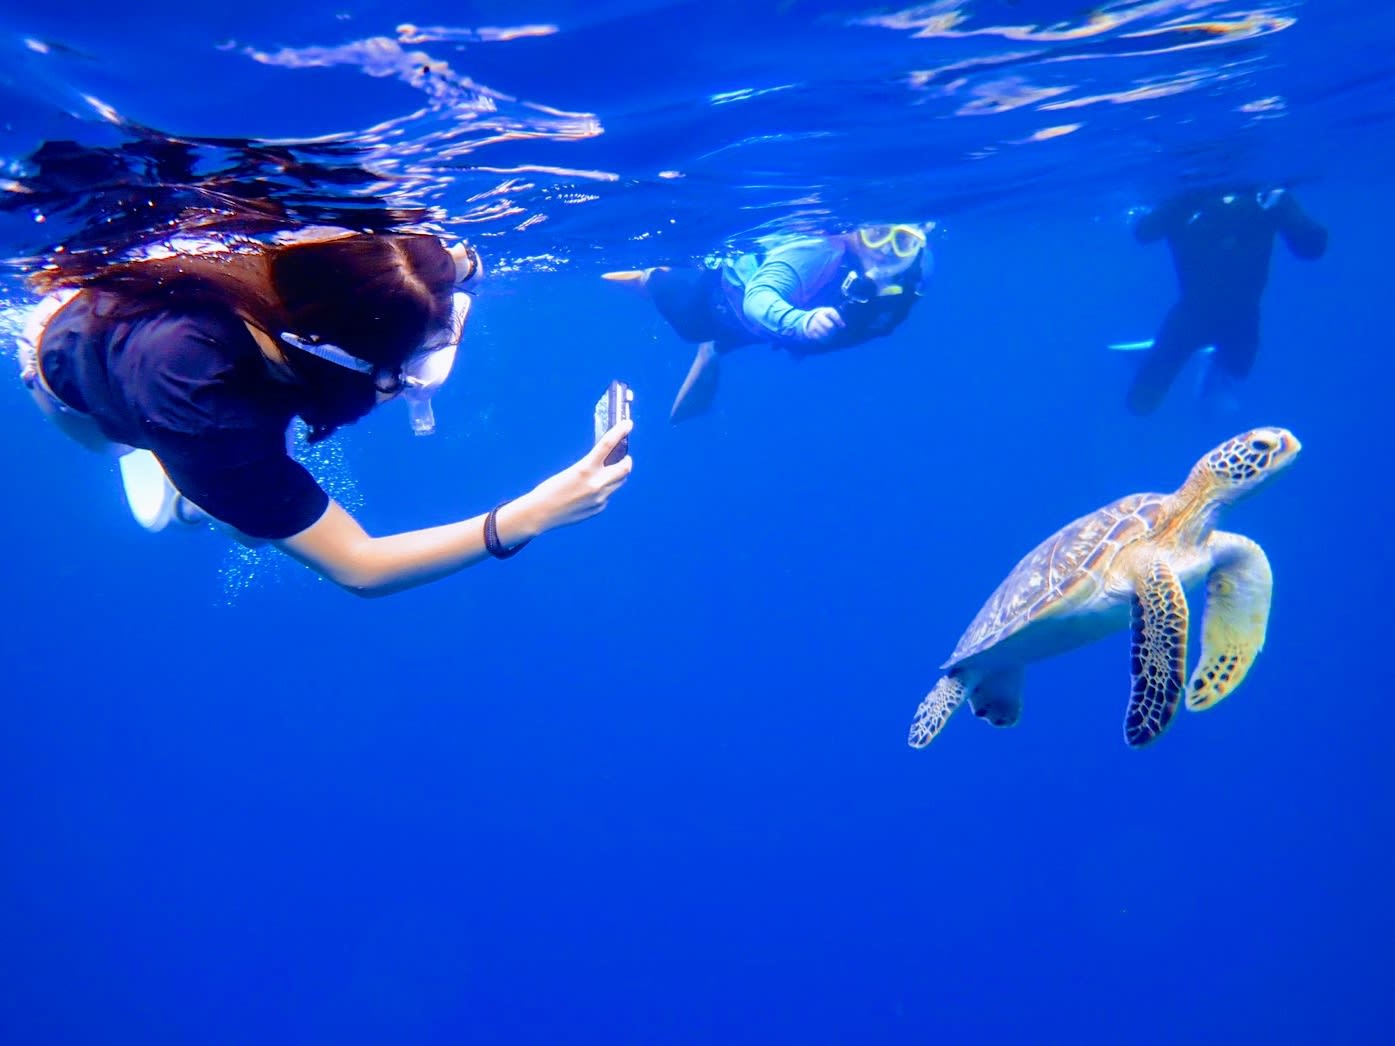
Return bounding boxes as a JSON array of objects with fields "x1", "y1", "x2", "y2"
[{"x1": 280, "y1": 243, "x2": 484, "y2": 435}]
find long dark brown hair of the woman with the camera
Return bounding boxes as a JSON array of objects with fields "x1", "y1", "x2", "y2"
[{"x1": 32, "y1": 233, "x2": 455, "y2": 442}]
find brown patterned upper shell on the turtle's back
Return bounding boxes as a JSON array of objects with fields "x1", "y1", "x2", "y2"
[{"x1": 943, "y1": 494, "x2": 1168, "y2": 668}]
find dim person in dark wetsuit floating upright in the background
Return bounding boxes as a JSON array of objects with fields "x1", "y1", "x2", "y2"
[{"x1": 1129, "y1": 185, "x2": 1327, "y2": 414}]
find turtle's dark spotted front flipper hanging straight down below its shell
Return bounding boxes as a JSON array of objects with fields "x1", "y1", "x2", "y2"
[{"x1": 1124, "y1": 559, "x2": 1187, "y2": 748}]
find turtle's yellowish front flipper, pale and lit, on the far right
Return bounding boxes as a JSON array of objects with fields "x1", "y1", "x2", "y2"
[{"x1": 1187, "y1": 530, "x2": 1274, "y2": 711}]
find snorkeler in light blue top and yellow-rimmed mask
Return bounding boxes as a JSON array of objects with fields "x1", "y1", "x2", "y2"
[{"x1": 605, "y1": 225, "x2": 933, "y2": 423}]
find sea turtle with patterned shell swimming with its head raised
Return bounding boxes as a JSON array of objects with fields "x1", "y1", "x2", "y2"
[{"x1": 910, "y1": 428, "x2": 1300, "y2": 748}]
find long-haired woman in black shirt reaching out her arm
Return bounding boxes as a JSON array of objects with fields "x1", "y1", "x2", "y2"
[{"x1": 20, "y1": 233, "x2": 631, "y2": 596}]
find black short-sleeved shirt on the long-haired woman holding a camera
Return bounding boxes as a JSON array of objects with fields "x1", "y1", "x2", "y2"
[{"x1": 39, "y1": 290, "x2": 329, "y2": 540}]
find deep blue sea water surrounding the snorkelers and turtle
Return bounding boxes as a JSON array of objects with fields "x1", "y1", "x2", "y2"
[{"x1": 0, "y1": 0, "x2": 1395, "y2": 1043}]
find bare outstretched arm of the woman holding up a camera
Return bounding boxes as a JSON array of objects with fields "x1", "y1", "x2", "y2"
[{"x1": 275, "y1": 421, "x2": 633, "y2": 597}]
